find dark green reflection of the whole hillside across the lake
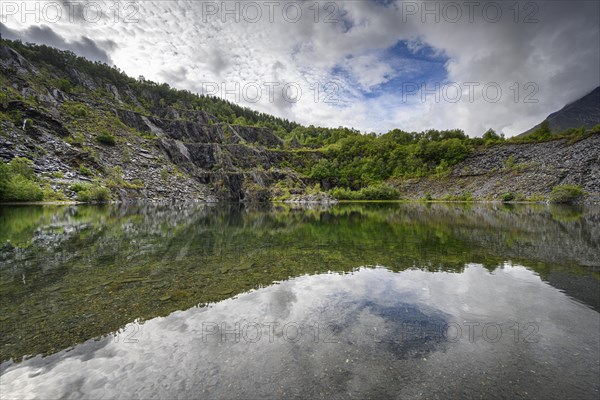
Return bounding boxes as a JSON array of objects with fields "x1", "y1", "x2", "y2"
[{"x1": 0, "y1": 203, "x2": 600, "y2": 357}]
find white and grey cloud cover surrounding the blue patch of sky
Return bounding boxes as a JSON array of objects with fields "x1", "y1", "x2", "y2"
[{"x1": 3, "y1": 1, "x2": 600, "y2": 135}]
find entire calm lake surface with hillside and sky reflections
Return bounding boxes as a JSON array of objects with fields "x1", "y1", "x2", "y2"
[{"x1": 0, "y1": 203, "x2": 600, "y2": 400}]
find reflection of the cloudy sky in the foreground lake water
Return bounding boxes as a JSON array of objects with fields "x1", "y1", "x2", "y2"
[{"x1": 1, "y1": 264, "x2": 600, "y2": 399}]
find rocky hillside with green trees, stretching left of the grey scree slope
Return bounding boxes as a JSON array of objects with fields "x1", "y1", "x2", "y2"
[{"x1": 0, "y1": 40, "x2": 600, "y2": 201}]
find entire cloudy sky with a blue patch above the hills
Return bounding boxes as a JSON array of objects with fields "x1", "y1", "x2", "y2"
[{"x1": 0, "y1": 0, "x2": 600, "y2": 136}]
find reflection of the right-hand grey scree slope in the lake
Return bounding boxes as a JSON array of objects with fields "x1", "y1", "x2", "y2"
[{"x1": 394, "y1": 205, "x2": 600, "y2": 267}]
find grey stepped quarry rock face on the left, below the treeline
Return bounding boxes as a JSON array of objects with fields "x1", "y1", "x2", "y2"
[{"x1": 0, "y1": 41, "x2": 324, "y2": 201}]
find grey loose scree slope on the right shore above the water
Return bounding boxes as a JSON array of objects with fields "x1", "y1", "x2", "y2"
[{"x1": 397, "y1": 134, "x2": 600, "y2": 202}]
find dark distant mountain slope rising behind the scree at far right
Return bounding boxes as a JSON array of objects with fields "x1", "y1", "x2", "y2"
[{"x1": 519, "y1": 86, "x2": 600, "y2": 136}]
